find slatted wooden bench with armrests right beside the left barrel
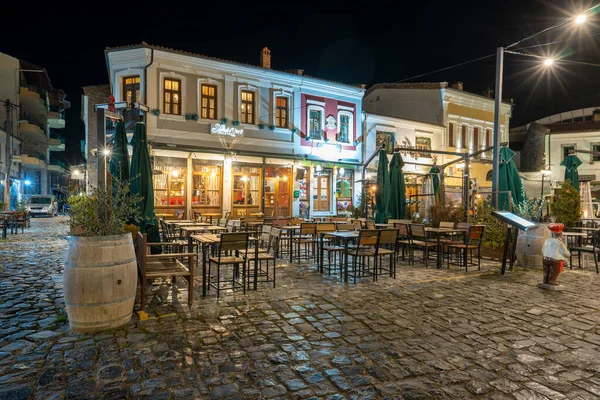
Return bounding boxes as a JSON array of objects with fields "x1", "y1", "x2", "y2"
[{"x1": 135, "y1": 232, "x2": 196, "y2": 310}]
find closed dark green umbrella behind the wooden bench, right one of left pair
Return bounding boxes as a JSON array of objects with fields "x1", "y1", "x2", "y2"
[{"x1": 129, "y1": 122, "x2": 160, "y2": 247}]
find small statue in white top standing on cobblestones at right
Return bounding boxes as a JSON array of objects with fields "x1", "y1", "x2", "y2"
[{"x1": 538, "y1": 223, "x2": 571, "y2": 290}]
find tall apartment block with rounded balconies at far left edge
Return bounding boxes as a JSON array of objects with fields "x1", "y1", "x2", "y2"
[{"x1": 0, "y1": 53, "x2": 70, "y2": 207}]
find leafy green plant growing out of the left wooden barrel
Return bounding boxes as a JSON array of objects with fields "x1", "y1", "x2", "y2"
[{"x1": 68, "y1": 176, "x2": 142, "y2": 237}]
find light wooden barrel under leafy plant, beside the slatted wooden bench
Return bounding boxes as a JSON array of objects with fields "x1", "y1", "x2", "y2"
[{"x1": 63, "y1": 233, "x2": 137, "y2": 333}]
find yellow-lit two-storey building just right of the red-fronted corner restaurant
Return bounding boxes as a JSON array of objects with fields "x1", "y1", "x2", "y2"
[{"x1": 363, "y1": 82, "x2": 512, "y2": 199}]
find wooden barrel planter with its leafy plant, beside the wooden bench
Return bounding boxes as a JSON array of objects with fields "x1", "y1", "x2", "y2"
[{"x1": 63, "y1": 176, "x2": 141, "y2": 333}]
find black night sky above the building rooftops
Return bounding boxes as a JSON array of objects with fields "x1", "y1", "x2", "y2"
[{"x1": 0, "y1": 0, "x2": 600, "y2": 163}]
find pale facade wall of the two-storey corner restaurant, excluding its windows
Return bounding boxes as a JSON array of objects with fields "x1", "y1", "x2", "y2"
[{"x1": 107, "y1": 46, "x2": 364, "y2": 215}]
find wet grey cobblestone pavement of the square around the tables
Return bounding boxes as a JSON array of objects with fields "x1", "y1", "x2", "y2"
[{"x1": 0, "y1": 218, "x2": 600, "y2": 400}]
